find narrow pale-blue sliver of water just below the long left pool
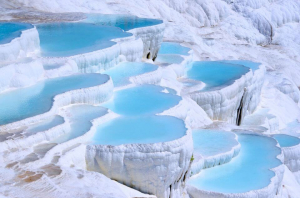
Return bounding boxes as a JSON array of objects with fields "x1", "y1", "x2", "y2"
[{"x1": 25, "y1": 115, "x2": 65, "y2": 135}]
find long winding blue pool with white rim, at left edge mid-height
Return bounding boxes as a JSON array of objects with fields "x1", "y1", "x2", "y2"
[{"x1": 0, "y1": 74, "x2": 113, "y2": 132}]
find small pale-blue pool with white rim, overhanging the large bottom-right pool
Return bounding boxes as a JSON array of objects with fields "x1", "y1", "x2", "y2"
[{"x1": 191, "y1": 129, "x2": 241, "y2": 175}]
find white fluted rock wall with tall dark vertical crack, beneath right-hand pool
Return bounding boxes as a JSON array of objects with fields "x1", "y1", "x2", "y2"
[{"x1": 187, "y1": 65, "x2": 265, "y2": 125}]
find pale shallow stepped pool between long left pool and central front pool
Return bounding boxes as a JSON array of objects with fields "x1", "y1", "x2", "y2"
[{"x1": 52, "y1": 105, "x2": 107, "y2": 144}]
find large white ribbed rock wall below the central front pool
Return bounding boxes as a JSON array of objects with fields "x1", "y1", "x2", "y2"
[{"x1": 86, "y1": 125, "x2": 193, "y2": 198}]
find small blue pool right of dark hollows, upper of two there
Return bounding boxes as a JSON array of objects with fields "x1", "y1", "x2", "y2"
[{"x1": 158, "y1": 42, "x2": 191, "y2": 56}]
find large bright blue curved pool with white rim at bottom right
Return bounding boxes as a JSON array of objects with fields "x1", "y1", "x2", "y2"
[{"x1": 187, "y1": 132, "x2": 285, "y2": 198}]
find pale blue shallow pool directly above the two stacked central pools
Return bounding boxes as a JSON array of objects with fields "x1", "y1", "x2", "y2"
[{"x1": 103, "y1": 62, "x2": 158, "y2": 87}]
